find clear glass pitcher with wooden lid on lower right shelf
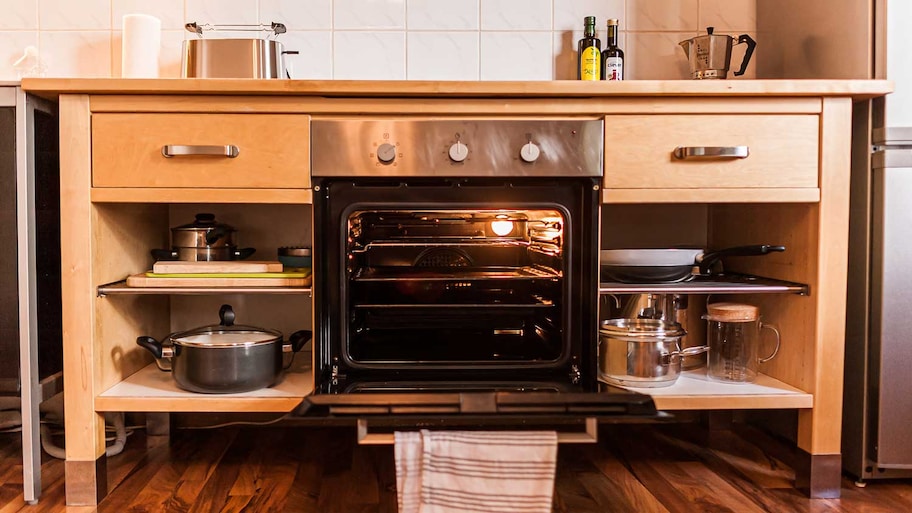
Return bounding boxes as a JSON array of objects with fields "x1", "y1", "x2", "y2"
[{"x1": 703, "y1": 303, "x2": 780, "y2": 383}]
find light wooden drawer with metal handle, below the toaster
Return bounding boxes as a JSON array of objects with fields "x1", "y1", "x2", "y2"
[{"x1": 92, "y1": 113, "x2": 310, "y2": 189}]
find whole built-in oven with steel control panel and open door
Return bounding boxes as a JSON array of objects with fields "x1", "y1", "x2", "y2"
[{"x1": 308, "y1": 118, "x2": 656, "y2": 419}]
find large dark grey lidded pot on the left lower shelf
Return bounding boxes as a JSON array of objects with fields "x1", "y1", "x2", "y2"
[{"x1": 136, "y1": 305, "x2": 313, "y2": 394}]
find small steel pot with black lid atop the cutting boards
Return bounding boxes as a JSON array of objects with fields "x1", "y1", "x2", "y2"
[{"x1": 152, "y1": 213, "x2": 256, "y2": 262}]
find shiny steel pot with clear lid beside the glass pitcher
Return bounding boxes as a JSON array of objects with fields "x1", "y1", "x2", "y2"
[{"x1": 599, "y1": 319, "x2": 706, "y2": 388}]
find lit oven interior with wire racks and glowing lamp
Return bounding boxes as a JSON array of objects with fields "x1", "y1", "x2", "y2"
[{"x1": 346, "y1": 208, "x2": 566, "y2": 367}]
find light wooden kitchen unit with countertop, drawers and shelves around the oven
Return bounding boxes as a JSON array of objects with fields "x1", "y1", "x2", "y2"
[{"x1": 23, "y1": 79, "x2": 890, "y2": 505}]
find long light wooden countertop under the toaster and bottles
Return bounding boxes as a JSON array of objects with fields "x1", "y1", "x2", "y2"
[{"x1": 22, "y1": 78, "x2": 893, "y2": 100}]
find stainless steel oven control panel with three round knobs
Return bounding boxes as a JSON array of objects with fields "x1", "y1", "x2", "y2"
[{"x1": 311, "y1": 118, "x2": 604, "y2": 177}]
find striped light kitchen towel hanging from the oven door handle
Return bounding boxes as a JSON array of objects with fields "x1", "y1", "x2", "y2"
[{"x1": 395, "y1": 430, "x2": 557, "y2": 513}]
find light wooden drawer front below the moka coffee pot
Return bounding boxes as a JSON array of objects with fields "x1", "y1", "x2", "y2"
[{"x1": 605, "y1": 114, "x2": 819, "y2": 189}]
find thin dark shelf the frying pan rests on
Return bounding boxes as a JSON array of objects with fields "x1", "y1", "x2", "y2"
[{"x1": 599, "y1": 274, "x2": 810, "y2": 296}]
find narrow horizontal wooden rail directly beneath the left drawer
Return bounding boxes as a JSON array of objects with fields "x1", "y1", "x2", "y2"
[{"x1": 91, "y1": 187, "x2": 313, "y2": 204}]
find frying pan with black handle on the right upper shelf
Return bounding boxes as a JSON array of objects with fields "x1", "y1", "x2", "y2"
[{"x1": 599, "y1": 244, "x2": 785, "y2": 283}]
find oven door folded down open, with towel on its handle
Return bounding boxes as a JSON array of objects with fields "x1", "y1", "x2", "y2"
[{"x1": 299, "y1": 381, "x2": 671, "y2": 444}]
